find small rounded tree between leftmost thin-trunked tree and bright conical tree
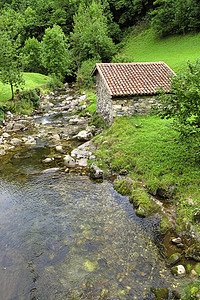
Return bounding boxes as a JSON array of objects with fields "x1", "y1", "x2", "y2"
[{"x1": 23, "y1": 37, "x2": 44, "y2": 73}]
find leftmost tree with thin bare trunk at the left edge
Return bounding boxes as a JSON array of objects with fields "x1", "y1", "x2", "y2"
[{"x1": 0, "y1": 31, "x2": 24, "y2": 100}]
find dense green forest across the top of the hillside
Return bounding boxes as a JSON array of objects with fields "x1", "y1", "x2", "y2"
[{"x1": 0, "y1": 0, "x2": 200, "y2": 96}]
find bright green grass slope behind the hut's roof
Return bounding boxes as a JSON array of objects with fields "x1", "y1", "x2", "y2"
[{"x1": 121, "y1": 28, "x2": 200, "y2": 72}]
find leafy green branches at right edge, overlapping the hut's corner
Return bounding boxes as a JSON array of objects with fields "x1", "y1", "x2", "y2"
[{"x1": 159, "y1": 61, "x2": 200, "y2": 137}]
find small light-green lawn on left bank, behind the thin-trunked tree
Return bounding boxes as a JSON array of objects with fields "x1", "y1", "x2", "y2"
[{"x1": 0, "y1": 73, "x2": 49, "y2": 103}]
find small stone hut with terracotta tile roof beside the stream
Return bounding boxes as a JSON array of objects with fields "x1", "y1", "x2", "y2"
[{"x1": 91, "y1": 62, "x2": 175, "y2": 124}]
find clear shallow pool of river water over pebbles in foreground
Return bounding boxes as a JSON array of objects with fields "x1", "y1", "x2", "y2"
[{"x1": 0, "y1": 89, "x2": 183, "y2": 300}]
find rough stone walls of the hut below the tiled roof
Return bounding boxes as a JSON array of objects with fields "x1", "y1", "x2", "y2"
[{"x1": 96, "y1": 73, "x2": 158, "y2": 124}]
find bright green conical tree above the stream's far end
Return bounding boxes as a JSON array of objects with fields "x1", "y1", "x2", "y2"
[{"x1": 42, "y1": 25, "x2": 70, "y2": 79}]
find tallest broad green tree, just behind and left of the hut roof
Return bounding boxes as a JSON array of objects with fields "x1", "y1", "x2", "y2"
[{"x1": 71, "y1": 1, "x2": 115, "y2": 67}]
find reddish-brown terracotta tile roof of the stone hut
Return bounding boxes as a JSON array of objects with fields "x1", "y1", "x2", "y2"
[{"x1": 91, "y1": 62, "x2": 175, "y2": 96}]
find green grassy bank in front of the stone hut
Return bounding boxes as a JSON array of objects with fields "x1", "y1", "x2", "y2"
[{"x1": 96, "y1": 115, "x2": 200, "y2": 227}]
